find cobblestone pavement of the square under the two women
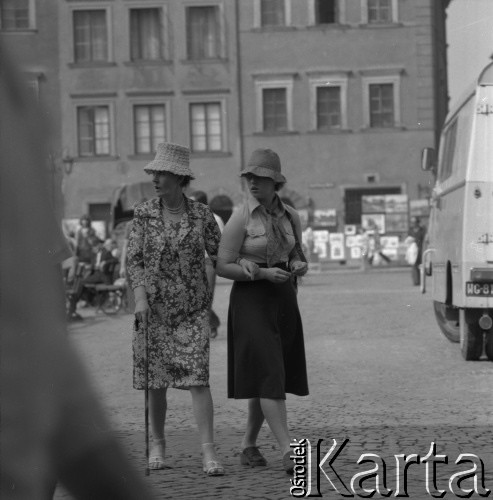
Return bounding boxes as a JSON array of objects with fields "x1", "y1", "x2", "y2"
[{"x1": 55, "y1": 270, "x2": 493, "y2": 500}]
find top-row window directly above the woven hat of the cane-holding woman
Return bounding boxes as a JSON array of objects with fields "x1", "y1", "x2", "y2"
[{"x1": 130, "y1": 8, "x2": 164, "y2": 61}]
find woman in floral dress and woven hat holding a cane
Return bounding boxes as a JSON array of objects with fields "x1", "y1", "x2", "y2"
[{"x1": 127, "y1": 143, "x2": 224, "y2": 476}]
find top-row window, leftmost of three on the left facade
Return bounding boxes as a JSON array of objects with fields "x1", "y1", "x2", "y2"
[{"x1": 74, "y1": 10, "x2": 108, "y2": 63}]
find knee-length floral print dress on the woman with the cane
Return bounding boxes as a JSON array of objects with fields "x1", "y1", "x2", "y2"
[{"x1": 127, "y1": 198, "x2": 221, "y2": 389}]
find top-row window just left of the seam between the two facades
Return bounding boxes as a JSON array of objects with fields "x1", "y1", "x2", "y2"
[{"x1": 187, "y1": 5, "x2": 223, "y2": 60}]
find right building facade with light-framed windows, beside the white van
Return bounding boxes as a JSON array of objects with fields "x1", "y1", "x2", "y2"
[{"x1": 236, "y1": 0, "x2": 447, "y2": 228}]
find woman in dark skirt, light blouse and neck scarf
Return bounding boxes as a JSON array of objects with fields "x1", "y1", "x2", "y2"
[{"x1": 217, "y1": 149, "x2": 308, "y2": 474}]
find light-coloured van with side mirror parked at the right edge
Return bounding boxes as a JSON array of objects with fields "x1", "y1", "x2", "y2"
[{"x1": 421, "y1": 63, "x2": 493, "y2": 361}]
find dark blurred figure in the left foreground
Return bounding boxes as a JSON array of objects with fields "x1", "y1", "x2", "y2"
[{"x1": 0, "y1": 48, "x2": 151, "y2": 500}]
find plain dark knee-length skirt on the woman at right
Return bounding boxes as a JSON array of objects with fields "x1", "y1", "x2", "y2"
[{"x1": 228, "y1": 280, "x2": 308, "y2": 399}]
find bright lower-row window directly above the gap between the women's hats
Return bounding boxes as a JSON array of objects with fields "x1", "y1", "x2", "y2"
[{"x1": 190, "y1": 102, "x2": 223, "y2": 152}]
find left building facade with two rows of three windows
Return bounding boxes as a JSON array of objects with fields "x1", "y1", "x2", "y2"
[{"x1": 60, "y1": 0, "x2": 242, "y2": 229}]
